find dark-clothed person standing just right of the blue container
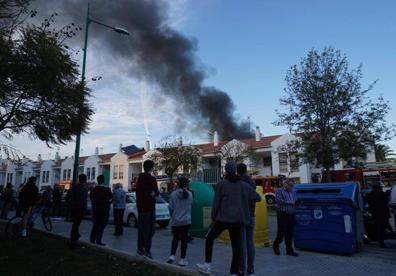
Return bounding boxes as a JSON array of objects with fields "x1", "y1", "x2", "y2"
[{"x1": 366, "y1": 184, "x2": 390, "y2": 248}]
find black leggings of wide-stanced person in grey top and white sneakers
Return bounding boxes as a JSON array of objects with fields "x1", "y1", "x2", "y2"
[{"x1": 205, "y1": 221, "x2": 243, "y2": 274}]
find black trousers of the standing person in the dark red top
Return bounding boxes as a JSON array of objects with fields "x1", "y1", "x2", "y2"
[{"x1": 138, "y1": 211, "x2": 155, "y2": 254}]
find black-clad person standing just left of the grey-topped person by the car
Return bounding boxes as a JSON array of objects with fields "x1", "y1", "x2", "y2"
[{"x1": 89, "y1": 175, "x2": 113, "y2": 246}]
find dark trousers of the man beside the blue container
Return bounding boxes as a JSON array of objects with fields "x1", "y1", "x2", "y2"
[{"x1": 273, "y1": 211, "x2": 294, "y2": 253}]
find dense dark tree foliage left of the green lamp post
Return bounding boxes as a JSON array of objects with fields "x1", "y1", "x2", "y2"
[{"x1": 0, "y1": 0, "x2": 93, "y2": 151}]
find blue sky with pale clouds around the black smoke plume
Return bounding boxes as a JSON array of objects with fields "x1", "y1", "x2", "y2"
[{"x1": 3, "y1": 0, "x2": 396, "y2": 159}]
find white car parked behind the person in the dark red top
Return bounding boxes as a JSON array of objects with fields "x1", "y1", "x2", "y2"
[{"x1": 124, "y1": 193, "x2": 170, "y2": 228}]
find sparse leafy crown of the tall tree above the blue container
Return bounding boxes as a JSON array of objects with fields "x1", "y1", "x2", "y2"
[{"x1": 275, "y1": 48, "x2": 395, "y2": 174}]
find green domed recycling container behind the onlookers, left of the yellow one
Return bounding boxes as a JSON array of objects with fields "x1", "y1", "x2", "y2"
[{"x1": 190, "y1": 181, "x2": 214, "y2": 238}]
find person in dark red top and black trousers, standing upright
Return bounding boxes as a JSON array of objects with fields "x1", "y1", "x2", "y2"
[{"x1": 136, "y1": 160, "x2": 159, "y2": 259}]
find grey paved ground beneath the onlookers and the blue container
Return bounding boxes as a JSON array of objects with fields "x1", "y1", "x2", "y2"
[{"x1": 25, "y1": 215, "x2": 396, "y2": 276}]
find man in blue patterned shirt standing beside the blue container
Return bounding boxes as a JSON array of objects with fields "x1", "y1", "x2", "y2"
[{"x1": 273, "y1": 179, "x2": 298, "y2": 257}]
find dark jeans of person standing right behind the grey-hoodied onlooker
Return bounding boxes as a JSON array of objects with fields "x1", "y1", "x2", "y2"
[{"x1": 240, "y1": 217, "x2": 256, "y2": 274}]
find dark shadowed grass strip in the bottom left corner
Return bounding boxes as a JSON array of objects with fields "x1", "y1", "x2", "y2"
[{"x1": 0, "y1": 229, "x2": 177, "y2": 276}]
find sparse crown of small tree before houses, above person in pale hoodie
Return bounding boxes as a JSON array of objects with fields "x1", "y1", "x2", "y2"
[{"x1": 149, "y1": 136, "x2": 201, "y2": 179}]
